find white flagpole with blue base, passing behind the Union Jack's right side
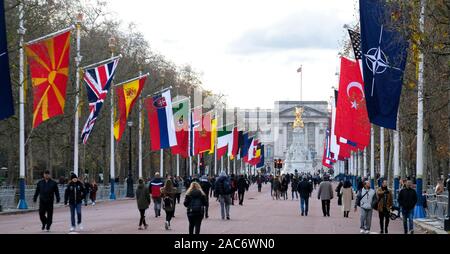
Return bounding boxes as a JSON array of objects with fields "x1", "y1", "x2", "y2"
[{"x1": 109, "y1": 37, "x2": 116, "y2": 200}]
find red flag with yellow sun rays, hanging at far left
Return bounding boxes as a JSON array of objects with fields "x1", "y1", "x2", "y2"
[{"x1": 25, "y1": 31, "x2": 70, "y2": 128}]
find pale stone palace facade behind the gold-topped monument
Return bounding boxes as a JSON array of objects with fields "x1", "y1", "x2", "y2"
[{"x1": 236, "y1": 101, "x2": 330, "y2": 172}]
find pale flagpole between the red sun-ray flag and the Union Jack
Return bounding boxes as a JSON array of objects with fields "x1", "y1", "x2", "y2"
[{"x1": 73, "y1": 13, "x2": 83, "y2": 175}]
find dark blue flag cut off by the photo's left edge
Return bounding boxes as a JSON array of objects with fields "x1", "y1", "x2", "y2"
[{"x1": 0, "y1": 0, "x2": 14, "y2": 120}]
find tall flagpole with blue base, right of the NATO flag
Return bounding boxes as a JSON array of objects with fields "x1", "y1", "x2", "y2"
[{"x1": 414, "y1": 0, "x2": 426, "y2": 218}]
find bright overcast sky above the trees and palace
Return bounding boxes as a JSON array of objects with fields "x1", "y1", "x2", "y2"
[{"x1": 108, "y1": 0, "x2": 357, "y2": 108}]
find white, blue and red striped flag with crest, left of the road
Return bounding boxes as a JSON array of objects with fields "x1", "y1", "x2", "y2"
[{"x1": 145, "y1": 90, "x2": 177, "y2": 151}]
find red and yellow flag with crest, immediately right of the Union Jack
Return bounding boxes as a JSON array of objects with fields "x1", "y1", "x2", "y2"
[{"x1": 114, "y1": 75, "x2": 147, "y2": 141}]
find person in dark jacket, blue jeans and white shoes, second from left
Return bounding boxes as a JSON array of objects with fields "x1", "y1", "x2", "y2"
[{"x1": 64, "y1": 173, "x2": 85, "y2": 232}]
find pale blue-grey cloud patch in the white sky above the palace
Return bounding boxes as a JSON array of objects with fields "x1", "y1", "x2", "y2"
[{"x1": 228, "y1": 12, "x2": 342, "y2": 54}]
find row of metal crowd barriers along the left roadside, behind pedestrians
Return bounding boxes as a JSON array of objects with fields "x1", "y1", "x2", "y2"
[{"x1": 0, "y1": 184, "x2": 137, "y2": 210}]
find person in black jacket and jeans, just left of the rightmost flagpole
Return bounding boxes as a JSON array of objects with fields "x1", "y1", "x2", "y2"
[{"x1": 398, "y1": 180, "x2": 417, "y2": 234}]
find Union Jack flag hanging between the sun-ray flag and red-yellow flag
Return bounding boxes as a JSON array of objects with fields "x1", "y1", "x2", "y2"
[{"x1": 81, "y1": 58, "x2": 119, "y2": 144}]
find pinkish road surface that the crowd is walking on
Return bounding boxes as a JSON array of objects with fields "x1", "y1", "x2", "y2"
[{"x1": 0, "y1": 184, "x2": 426, "y2": 234}]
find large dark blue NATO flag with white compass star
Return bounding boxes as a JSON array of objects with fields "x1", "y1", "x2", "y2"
[{"x1": 359, "y1": 0, "x2": 408, "y2": 129}]
